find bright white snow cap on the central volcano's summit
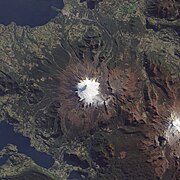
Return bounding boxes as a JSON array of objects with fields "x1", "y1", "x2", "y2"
[{"x1": 76, "y1": 77, "x2": 105, "y2": 106}]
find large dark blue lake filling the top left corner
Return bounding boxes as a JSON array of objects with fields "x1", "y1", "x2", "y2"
[{"x1": 0, "y1": 0, "x2": 64, "y2": 27}]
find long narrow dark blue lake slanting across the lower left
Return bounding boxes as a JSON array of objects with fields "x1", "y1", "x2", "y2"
[{"x1": 0, "y1": 121, "x2": 54, "y2": 168}]
